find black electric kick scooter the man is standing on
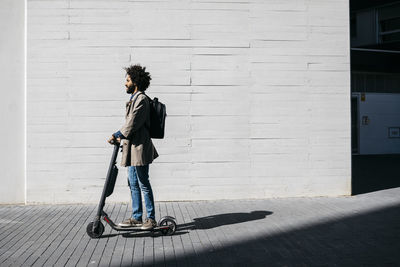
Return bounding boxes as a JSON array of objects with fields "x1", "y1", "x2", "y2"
[{"x1": 86, "y1": 141, "x2": 176, "y2": 238}]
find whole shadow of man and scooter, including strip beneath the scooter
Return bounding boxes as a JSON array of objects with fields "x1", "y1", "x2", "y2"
[{"x1": 119, "y1": 210, "x2": 272, "y2": 237}]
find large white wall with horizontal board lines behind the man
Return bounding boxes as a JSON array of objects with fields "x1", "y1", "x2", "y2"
[{"x1": 27, "y1": 0, "x2": 351, "y2": 203}]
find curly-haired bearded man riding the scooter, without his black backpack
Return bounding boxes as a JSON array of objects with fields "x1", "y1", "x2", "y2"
[{"x1": 108, "y1": 65, "x2": 158, "y2": 230}]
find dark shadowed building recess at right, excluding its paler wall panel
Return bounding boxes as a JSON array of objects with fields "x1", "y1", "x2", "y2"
[{"x1": 350, "y1": 0, "x2": 400, "y2": 195}]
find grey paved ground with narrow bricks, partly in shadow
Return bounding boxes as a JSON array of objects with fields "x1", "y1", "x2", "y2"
[{"x1": 0, "y1": 188, "x2": 400, "y2": 266}]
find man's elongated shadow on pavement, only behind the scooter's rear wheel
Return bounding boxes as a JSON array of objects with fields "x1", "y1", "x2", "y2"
[{"x1": 177, "y1": 210, "x2": 272, "y2": 231}]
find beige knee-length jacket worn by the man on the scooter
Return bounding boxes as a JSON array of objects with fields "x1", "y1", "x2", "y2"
[{"x1": 120, "y1": 92, "x2": 158, "y2": 167}]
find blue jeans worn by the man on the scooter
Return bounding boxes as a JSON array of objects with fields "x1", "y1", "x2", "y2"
[{"x1": 128, "y1": 164, "x2": 155, "y2": 221}]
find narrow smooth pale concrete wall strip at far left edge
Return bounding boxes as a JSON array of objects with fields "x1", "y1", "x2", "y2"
[{"x1": 0, "y1": 0, "x2": 25, "y2": 203}]
